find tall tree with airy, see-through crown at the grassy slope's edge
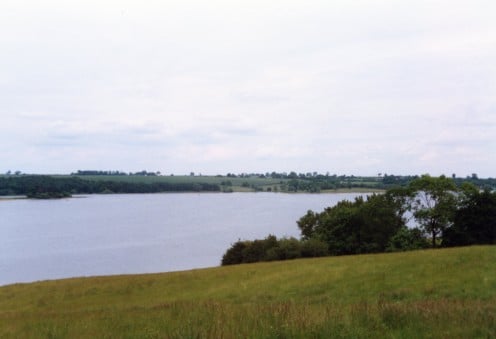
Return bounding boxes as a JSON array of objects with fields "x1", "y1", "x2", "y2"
[{"x1": 408, "y1": 175, "x2": 457, "y2": 247}]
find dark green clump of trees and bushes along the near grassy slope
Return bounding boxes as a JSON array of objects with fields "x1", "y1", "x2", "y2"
[{"x1": 222, "y1": 175, "x2": 496, "y2": 265}]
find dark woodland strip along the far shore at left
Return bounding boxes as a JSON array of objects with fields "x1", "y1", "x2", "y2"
[{"x1": 0, "y1": 175, "x2": 220, "y2": 198}]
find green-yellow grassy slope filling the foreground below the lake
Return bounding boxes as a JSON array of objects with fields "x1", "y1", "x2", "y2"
[{"x1": 0, "y1": 246, "x2": 496, "y2": 338}]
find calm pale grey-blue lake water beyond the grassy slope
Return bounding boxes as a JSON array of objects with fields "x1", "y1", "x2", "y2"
[{"x1": 0, "y1": 193, "x2": 360, "y2": 285}]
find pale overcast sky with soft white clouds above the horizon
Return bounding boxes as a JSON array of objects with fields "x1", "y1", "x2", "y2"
[{"x1": 0, "y1": 0, "x2": 496, "y2": 177}]
